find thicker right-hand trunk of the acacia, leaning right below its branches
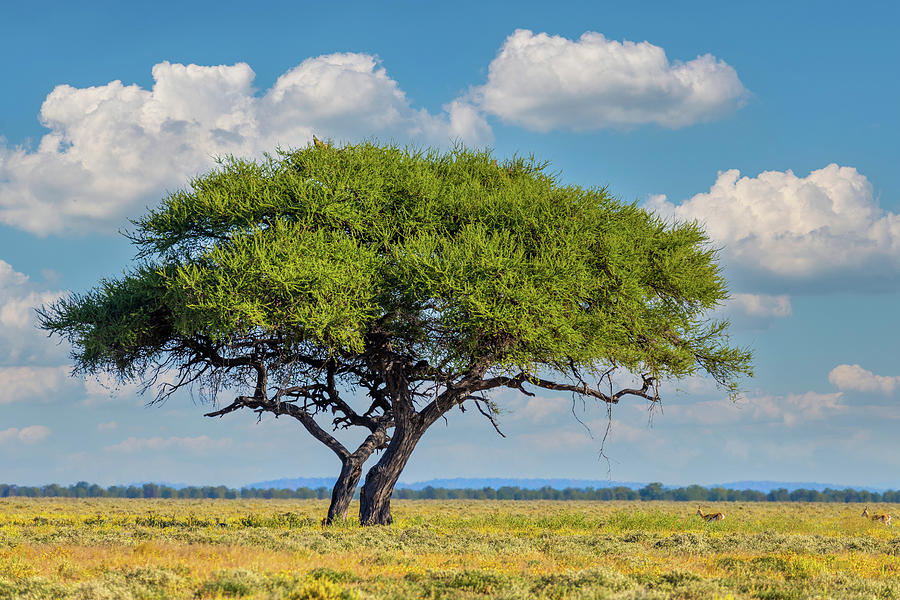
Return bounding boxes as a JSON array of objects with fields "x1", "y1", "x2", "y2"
[{"x1": 359, "y1": 420, "x2": 428, "y2": 525}]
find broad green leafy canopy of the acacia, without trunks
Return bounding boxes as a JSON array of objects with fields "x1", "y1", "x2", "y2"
[{"x1": 38, "y1": 143, "x2": 750, "y2": 389}]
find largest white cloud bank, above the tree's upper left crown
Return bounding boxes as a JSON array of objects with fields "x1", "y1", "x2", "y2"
[{"x1": 0, "y1": 53, "x2": 491, "y2": 235}]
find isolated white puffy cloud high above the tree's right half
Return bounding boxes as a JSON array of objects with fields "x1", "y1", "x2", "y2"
[{"x1": 471, "y1": 29, "x2": 747, "y2": 131}]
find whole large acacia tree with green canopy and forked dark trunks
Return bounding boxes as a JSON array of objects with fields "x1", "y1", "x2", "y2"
[{"x1": 40, "y1": 143, "x2": 751, "y2": 524}]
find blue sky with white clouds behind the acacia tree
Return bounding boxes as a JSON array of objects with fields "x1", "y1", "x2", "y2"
[{"x1": 0, "y1": 2, "x2": 900, "y2": 488}]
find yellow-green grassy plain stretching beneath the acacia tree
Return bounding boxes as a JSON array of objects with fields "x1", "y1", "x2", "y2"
[{"x1": 0, "y1": 498, "x2": 900, "y2": 600}]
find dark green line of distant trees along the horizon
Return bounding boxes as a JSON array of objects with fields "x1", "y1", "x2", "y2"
[{"x1": 0, "y1": 481, "x2": 900, "y2": 503}]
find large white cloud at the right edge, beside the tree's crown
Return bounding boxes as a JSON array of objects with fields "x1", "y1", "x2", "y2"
[{"x1": 645, "y1": 164, "x2": 900, "y2": 289}]
